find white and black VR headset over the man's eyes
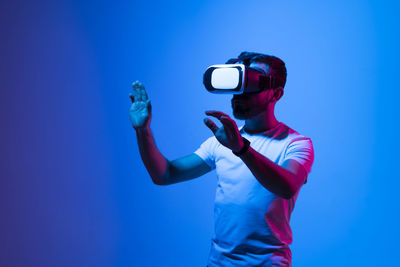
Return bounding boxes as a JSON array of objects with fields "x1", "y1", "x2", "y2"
[{"x1": 203, "y1": 64, "x2": 273, "y2": 94}]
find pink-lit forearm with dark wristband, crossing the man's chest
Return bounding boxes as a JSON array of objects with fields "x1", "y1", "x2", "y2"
[{"x1": 240, "y1": 147, "x2": 295, "y2": 198}]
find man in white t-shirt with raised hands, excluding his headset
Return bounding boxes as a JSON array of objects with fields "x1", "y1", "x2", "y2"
[{"x1": 130, "y1": 52, "x2": 314, "y2": 267}]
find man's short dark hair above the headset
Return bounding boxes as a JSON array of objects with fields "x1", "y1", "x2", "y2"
[{"x1": 225, "y1": 51, "x2": 287, "y2": 88}]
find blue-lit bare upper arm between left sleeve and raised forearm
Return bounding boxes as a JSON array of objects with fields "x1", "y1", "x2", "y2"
[{"x1": 165, "y1": 153, "x2": 211, "y2": 185}]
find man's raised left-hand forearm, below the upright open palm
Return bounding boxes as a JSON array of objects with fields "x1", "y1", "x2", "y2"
[{"x1": 136, "y1": 127, "x2": 169, "y2": 185}]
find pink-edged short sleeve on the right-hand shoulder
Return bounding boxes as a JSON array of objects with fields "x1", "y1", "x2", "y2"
[{"x1": 285, "y1": 137, "x2": 314, "y2": 183}]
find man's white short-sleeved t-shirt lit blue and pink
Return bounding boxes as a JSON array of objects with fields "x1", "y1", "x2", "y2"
[{"x1": 194, "y1": 122, "x2": 314, "y2": 267}]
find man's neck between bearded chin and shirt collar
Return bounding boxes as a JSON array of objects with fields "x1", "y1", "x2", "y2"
[{"x1": 244, "y1": 105, "x2": 279, "y2": 133}]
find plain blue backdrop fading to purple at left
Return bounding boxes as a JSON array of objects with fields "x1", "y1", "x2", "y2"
[{"x1": 0, "y1": 0, "x2": 400, "y2": 267}]
